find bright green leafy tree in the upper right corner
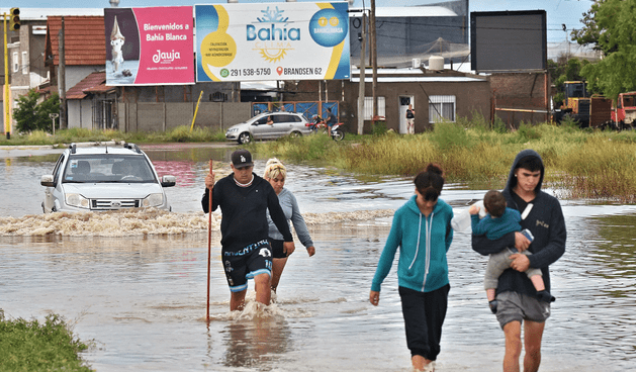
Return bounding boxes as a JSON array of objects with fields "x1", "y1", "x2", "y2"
[{"x1": 572, "y1": 0, "x2": 636, "y2": 99}]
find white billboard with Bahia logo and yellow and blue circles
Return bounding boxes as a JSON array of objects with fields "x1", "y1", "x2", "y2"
[{"x1": 195, "y1": 2, "x2": 351, "y2": 82}]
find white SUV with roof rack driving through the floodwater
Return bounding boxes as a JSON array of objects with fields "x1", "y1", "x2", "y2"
[{"x1": 40, "y1": 144, "x2": 176, "y2": 213}]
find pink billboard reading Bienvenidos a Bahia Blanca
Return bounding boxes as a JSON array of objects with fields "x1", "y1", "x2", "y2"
[{"x1": 104, "y1": 6, "x2": 194, "y2": 85}]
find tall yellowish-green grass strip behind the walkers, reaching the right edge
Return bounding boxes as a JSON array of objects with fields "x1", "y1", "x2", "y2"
[{"x1": 252, "y1": 119, "x2": 636, "y2": 203}]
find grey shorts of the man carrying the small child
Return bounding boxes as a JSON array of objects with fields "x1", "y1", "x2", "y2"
[{"x1": 497, "y1": 292, "x2": 550, "y2": 329}]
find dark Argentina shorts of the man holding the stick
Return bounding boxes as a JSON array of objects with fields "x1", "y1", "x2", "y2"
[{"x1": 223, "y1": 239, "x2": 272, "y2": 292}]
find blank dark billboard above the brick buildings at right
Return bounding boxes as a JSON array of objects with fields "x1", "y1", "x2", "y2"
[{"x1": 470, "y1": 10, "x2": 548, "y2": 72}]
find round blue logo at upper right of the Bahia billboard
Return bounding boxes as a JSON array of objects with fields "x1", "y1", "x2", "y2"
[{"x1": 309, "y1": 9, "x2": 349, "y2": 48}]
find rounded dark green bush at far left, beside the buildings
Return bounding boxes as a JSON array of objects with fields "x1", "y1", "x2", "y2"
[{"x1": 13, "y1": 89, "x2": 60, "y2": 132}]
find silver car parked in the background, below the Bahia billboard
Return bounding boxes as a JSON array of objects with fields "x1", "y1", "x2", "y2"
[{"x1": 225, "y1": 112, "x2": 312, "y2": 144}]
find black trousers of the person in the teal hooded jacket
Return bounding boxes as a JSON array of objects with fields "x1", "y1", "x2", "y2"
[{"x1": 399, "y1": 284, "x2": 450, "y2": 360}]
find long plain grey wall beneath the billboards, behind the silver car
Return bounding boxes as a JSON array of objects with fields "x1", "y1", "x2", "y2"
[{"x1": 117, "y1": 102, "x2": 251, "y2": 132}]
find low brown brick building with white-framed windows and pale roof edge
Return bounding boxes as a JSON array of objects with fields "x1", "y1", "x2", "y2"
[{"x1": 286, "y1": 64, "x2": 492, "y2": 133}]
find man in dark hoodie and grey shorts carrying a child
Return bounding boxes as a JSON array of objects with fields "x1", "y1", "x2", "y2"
[{"x1": 472, "y1": 150, "x2": 567, "y2": 372}]
